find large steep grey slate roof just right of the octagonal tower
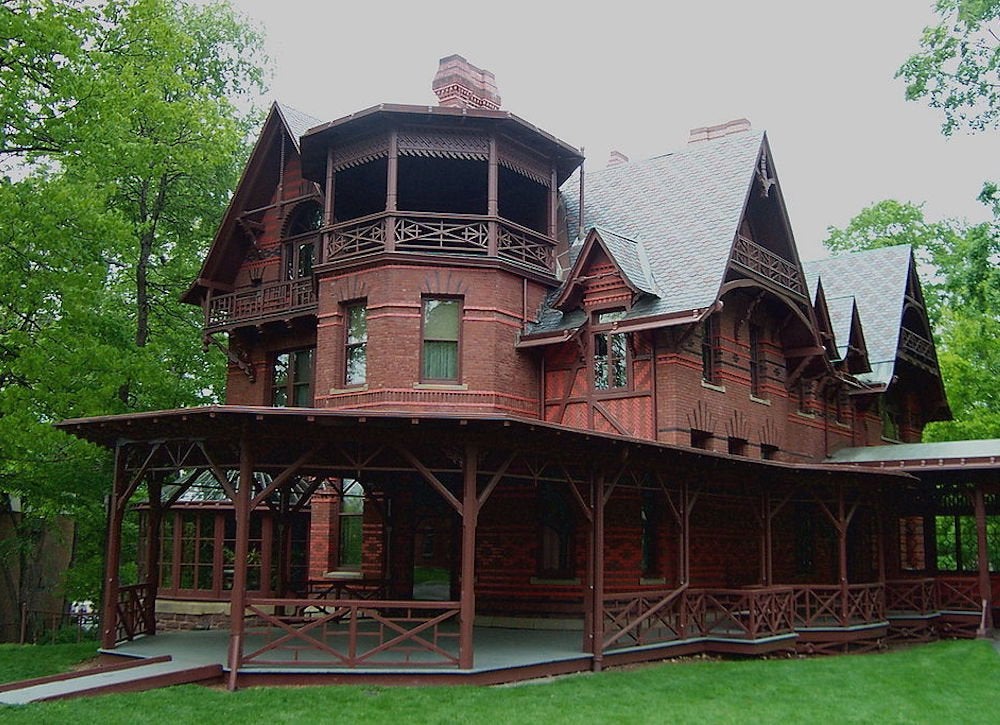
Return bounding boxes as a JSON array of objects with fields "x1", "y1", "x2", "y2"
[{"x1": 562, "y1": 131, "x2": 765, "y2": 315}]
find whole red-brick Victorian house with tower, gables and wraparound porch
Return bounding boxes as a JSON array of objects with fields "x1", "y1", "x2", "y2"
[{"x1": 60, "y1": 56, "x2": 998, "y2": 687}]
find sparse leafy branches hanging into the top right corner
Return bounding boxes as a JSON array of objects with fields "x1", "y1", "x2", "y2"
[{"x1": 896, "y1": 0, "x2": 1000, "y2": 136}]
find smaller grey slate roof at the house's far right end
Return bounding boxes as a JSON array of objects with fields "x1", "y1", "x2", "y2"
[{"x1": 803, "y1": 244, "x2": 912, "y2": 385}]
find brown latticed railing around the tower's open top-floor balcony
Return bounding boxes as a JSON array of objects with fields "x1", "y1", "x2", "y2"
[{"x1": 323, "y1": 212, "x2": 556, "y2": 274}]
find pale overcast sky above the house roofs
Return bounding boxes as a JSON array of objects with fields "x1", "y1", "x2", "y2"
[{"x1": 232, "y1": 0, "x2": 1000, "y2": 259}]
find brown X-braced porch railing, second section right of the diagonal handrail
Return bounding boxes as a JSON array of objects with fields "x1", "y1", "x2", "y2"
[{"x1": 794, "y1": 583, "x2": 885, "y2": 628}]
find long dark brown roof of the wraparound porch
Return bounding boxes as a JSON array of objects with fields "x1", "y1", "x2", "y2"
[{"x1": 56, "y1": 405, "x2": 915, "y2": 485}]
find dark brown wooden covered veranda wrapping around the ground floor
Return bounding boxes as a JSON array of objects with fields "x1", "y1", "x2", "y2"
[{"x1": 60, "y1": 406, "x2": 944, "y2": 688}]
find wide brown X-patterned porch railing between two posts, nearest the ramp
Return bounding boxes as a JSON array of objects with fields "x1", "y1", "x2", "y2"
[{"x1": 242, "y1": 599, "x2": 461, "y2": 668}]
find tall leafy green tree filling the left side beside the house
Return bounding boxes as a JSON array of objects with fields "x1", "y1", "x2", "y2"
[{"x1": 0, "y1": 0, "x2": 263, "y2": 628}]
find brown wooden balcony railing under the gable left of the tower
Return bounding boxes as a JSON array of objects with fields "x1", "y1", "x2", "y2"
[{"x1": 205, "y1": 278, "x2": 316, "y2": 330}]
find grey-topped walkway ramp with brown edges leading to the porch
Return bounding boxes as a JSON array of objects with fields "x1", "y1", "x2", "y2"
[{"x1": 0, "y1": 655, "x2": 222, "y2": 705}]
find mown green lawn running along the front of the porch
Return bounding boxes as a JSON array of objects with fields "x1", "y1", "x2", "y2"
[{"x1": 0, "y1": 641, "x2": 1000, "y2": 725}]
